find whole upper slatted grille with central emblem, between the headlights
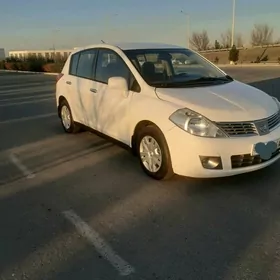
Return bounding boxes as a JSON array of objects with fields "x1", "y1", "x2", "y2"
[{"x1": 216, "y1": 112, "x2": 280, "y2": 137}]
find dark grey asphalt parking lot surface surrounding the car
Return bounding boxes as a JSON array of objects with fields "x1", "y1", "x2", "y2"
[{"x1": 0, "y1": 67, "x2": 280, "y2": 280}]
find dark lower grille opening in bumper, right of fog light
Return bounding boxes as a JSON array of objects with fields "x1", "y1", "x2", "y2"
[{"x1": 231, "y1": 149, "x2": 280, "y2": 169}]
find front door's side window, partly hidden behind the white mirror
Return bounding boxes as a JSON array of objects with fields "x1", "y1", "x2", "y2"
[{"x1": 95, "y1": 49, "x2": 140, "y2": 92}]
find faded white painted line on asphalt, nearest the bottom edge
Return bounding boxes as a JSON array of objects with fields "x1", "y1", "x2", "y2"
[{"x1": 63, "y1": 210, "x2": 135, "y2": 276}]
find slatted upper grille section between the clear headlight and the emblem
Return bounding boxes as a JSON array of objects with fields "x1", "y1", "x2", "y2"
[{"x1": 217, "y1": 122, "x2": 258, "y2": 137}]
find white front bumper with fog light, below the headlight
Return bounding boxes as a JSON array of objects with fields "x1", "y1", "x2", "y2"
[{"x1": 165, "y1": 126, "x2": 280, "y2": 178}]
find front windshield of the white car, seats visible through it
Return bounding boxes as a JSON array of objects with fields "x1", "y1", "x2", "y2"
[{"x1": 124, "y1": 48, "x2": 232, "y2": 87}]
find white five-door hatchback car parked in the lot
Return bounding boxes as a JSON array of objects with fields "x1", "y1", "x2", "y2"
[{"x1": 56, "y1": 43, "x2": 280, "y2": 180}]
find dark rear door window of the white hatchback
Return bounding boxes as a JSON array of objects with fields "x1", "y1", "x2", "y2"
[{"x1": 77, "y1": 49, "x2": 97, "y2": 79}]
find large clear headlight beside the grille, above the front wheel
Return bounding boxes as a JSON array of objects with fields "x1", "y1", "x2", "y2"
[{"x1": 169, "y1": 109, "x2": 227, "y2": 138}]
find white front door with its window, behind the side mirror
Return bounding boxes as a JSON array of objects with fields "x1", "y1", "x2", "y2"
[{"x1": 95, "y1": 49, "x2": 140, "y2": 144}]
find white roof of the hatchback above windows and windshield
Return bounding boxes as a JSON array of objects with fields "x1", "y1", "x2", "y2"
[{"x1": 74, "y1": 42, "x2": 184, "y2": 52}]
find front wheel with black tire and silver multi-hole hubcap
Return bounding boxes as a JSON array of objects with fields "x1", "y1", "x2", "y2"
[{"x1": 136, "y1": 126, "x2": 174, "y2": 180}]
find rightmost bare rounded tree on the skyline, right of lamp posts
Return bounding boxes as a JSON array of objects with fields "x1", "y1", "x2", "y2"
[{"x1": 251, "y1": 24, "x2": 273, "y2": 46}]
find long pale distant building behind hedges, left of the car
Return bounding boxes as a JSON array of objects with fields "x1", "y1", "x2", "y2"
[{"x1": 9, "y1": 49, "x2": 74, "y2": 59}]
